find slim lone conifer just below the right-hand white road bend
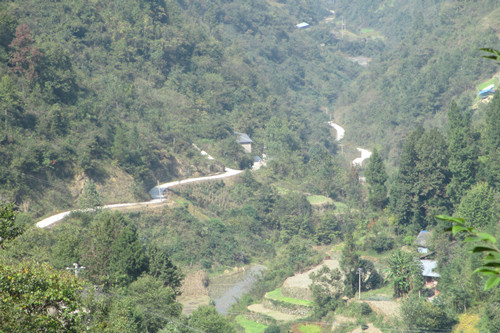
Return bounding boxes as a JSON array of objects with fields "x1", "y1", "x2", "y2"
[{"x1": 365, "y1": 149, "x2": 388, "y2": 209}]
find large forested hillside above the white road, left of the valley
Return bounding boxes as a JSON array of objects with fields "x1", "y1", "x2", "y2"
[{"x1": 1, "y1": 1, "x2": 360, "y2": 212}]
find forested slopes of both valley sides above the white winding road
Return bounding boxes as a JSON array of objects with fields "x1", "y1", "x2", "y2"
[{"x1": 0, "y1": 0, "x2": 499, "y2": 215}]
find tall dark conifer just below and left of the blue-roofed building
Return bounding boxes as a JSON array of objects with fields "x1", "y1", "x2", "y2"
[{"x1": 446, "y1": 102, "x2": 478, "y2": 205}]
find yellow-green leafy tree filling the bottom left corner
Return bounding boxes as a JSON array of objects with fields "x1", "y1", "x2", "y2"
[{"x1": 0, "y1": 262, "x2": 85, "y2": 333}]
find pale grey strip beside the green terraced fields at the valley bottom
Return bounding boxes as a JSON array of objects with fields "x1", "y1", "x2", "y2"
[{"x1": 210, "y1": 265, "x2": 266, "y2": 315}]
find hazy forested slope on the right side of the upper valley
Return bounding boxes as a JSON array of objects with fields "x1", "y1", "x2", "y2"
[{"x1": 336, "y1": 0, "x2": 500, "y2": 162}]
